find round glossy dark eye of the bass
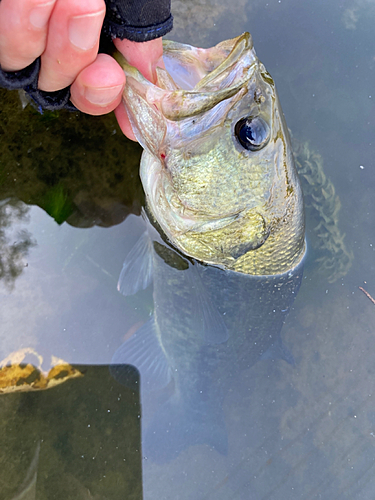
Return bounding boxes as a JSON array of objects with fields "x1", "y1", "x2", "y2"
[{"x1": 234, "y1": 116, "x2": 270, "y2": 151}]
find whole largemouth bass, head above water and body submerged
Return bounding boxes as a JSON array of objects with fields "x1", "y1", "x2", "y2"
[{"x1": 112, "y1": 33, "x2": 305, "y2": 460}]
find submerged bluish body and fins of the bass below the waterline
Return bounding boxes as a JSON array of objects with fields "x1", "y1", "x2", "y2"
[{"x1": 111, "y1": 223, "x2": 302, "y2": 462}]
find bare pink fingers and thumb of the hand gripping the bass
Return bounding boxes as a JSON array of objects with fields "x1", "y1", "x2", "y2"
[{"x1": 0, "y1": 0, "x2": 163, "y2": 140}]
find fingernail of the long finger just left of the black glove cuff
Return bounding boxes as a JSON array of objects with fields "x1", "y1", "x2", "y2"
[{"x1": 68, "y1": 12, "x2": 104, "y2": 50}]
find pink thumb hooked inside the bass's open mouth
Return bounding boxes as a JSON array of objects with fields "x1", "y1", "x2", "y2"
[{"x1": 114, "y1": 38, "x2": 164, "y2": 83}]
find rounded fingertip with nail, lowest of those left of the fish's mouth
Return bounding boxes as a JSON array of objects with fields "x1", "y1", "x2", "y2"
[{"x1": 70, "y1": 54, "x2": 125, "y2": 115}]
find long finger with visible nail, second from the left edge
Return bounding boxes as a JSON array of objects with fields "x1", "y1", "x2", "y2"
[{"x1": 38, "y1": 0, "x2": 105, "y2": 92}]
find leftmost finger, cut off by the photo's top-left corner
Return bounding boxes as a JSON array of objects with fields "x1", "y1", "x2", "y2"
[{"x1": 0, "y1": 0, "x2": 55, "y2": 71}]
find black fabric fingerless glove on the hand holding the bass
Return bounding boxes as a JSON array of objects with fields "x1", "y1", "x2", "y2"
[{"x1": 0, "y1": 0, "x2": 173, "y2": 111}]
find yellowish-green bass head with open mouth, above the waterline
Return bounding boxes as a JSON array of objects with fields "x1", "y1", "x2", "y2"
[{"x1": 119, "y1": 33, "x2": 305, "y2": 275}]
